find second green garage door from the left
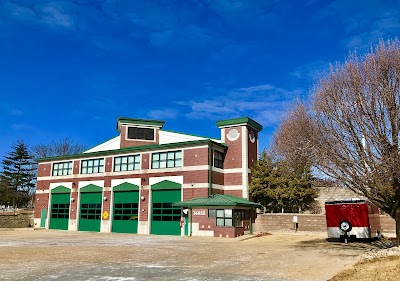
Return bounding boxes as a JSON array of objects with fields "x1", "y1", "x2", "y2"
[{"x1": 79, "y1": 184, "x2": 102, "y2": 232}]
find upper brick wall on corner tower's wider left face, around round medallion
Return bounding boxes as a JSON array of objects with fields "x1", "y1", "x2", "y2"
[{"x1": 224, "y1": 126, "x2": 243, "y2": 169}]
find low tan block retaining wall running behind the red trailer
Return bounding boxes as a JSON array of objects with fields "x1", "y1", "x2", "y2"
[{"x1": 254, "y1": 214, "x2": 396, "y2": 233}]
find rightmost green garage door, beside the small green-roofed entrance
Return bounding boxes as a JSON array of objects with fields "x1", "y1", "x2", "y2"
[{"x1": 151, "y1": 181, "x2": 181, "y2": 235}]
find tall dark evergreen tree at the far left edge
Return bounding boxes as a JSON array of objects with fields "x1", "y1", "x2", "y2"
[{"x1": 0, "y1": 141, "x2": 36, "y2": 205}]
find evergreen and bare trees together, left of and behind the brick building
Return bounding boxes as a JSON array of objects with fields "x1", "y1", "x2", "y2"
[{"x1": 0, "y1": 138, "x2": 86, "y2": 207}]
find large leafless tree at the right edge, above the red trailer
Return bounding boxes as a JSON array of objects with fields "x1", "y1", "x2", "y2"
[{"x1": 311, "y1": 39, "x2": 400, "y2": 245}]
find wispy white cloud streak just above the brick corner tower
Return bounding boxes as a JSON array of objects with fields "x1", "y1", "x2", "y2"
[{"x1": 179, "y1": 84, "x2": 303, "y2": 126}]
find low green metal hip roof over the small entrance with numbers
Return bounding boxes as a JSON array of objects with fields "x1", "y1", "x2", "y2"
[{"x1": 173, "y1": 194, "x2": 262, "y2": 208}]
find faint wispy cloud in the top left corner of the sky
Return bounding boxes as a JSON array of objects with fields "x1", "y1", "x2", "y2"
[{"x1": 3, "y1": 1, "x2": 74, "y2": 28}]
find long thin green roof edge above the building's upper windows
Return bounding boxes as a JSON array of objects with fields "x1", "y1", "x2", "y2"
[{"x1": 36, "y1": 139, "x2": 228, "y2": 162}]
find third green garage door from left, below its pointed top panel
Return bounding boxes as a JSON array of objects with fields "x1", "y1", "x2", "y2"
[{"x1": 112, "y1": 191, "x2": 139, "y2": 233}]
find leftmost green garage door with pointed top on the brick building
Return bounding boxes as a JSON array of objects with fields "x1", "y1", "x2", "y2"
[{"x1": 49, "y1": 186, "x2": 71, "y2": 230}]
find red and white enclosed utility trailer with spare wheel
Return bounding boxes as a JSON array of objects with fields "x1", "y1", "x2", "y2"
[{"x1": 325, "y1": 199, "x2": 381, "y2": 239}]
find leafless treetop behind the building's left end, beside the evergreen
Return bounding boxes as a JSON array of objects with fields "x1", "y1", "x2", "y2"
[{"x1": 32, "y1": 138, "x2": 87, "y2": 158}]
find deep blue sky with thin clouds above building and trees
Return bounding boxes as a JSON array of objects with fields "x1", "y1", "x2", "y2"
[{"x1": 0, "y1": 0, "x2": 400, "y2": 158}]
